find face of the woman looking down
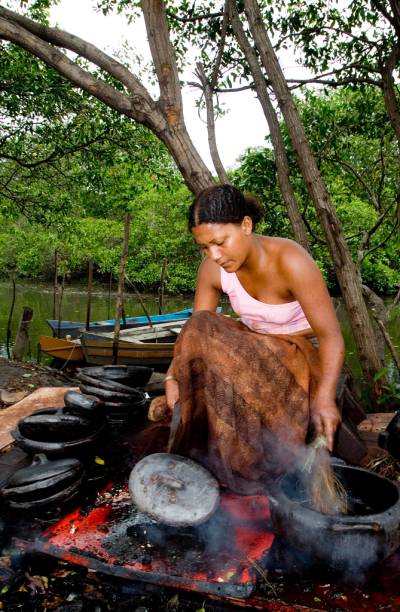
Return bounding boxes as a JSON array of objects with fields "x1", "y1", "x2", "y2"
[{"x1": 192, "y1": 217, "x2": 252, "y2": 272}]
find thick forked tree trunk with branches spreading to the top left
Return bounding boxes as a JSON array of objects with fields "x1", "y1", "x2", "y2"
[{"x1": 0, "y1": 0, "x2": 213, "y2": 193}]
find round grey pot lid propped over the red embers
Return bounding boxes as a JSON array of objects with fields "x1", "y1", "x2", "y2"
[{"x1": 129, "y1": 453, "x2": 219, "y2": 526}]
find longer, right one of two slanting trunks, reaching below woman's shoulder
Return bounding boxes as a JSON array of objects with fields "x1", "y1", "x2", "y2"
[{"x1": 244, "y1": 0, "x2": 382, "y2": 383}]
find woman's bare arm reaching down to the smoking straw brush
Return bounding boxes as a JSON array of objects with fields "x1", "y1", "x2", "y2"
[{"x1": 282, "y1": 243, "x2": 344, "y2": 450}]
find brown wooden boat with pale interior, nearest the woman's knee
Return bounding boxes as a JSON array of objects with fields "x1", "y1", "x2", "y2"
[{"x1": 81, "y1": 321, "x2": 185, "y2": 371}]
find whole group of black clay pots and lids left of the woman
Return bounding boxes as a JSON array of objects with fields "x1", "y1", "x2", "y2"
[{"x1": 0, "y1": 365, "x2": 152, "y2": 510}]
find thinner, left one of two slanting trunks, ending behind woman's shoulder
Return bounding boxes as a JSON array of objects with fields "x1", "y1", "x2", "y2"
[{"x1": 229, "y1": 0, "x2": 310, "y2": 253}]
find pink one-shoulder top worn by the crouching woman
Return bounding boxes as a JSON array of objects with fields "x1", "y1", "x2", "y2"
[{"x1": 221, "y1": 268, "x2": 311, "y2": 334}]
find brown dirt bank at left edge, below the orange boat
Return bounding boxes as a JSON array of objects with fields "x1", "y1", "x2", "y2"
[{"x1": 0, "y1": 357, "x2": 75, "y2": 406}]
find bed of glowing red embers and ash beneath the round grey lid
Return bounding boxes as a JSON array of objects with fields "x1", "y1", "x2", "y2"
[{"x1": 36, "y1": 486, "x2": 273, "y2": 597}]
